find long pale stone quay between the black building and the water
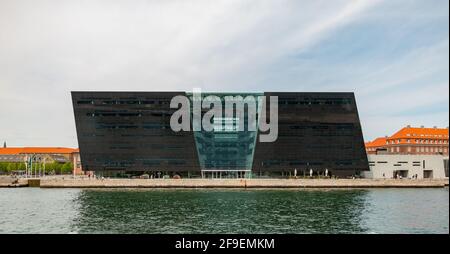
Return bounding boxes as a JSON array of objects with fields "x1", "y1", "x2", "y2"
[{"x1": 40, "y1": 179, "x2": 448, "y2": 188}]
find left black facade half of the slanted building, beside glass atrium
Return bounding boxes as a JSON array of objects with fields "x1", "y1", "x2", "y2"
[{"x1": 72, "y1": 92, "x2": 199, "y2": 175}]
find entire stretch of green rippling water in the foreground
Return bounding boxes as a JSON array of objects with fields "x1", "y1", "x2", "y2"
[{"x1": 0, "y1": 188, "x2": 449, "y2": 234}]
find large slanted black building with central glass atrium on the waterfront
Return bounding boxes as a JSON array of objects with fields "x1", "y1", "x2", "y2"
[{"x1": 72, "y1": 92, "x2": 369, "y2": 178}]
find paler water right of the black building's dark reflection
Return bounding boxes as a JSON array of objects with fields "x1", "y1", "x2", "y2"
[{"x1": 361, "y1": 188, "x2": 449, "y2": 234}]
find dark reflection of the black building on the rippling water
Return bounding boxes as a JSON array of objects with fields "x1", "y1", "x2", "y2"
[{"x1": 73, "y1": 190, "x2": 368, "y2": 233}]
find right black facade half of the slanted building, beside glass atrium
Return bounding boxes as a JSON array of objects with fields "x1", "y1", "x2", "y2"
[{"x1": 253, "y1": 93, "x2": 369, "y2": 175}]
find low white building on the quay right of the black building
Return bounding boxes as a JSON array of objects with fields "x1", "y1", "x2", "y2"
[{"x1": 363, "y1": 154, "x2": 448, "y2": 179}]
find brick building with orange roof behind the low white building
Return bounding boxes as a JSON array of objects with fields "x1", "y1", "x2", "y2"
[{"x1": 366, "y1": 125, "x2": 449, "y2": 156}]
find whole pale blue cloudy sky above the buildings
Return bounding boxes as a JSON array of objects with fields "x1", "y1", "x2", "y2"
[{"x1": 0, "y1": 0, "x2": 449, "y2": 147}]
